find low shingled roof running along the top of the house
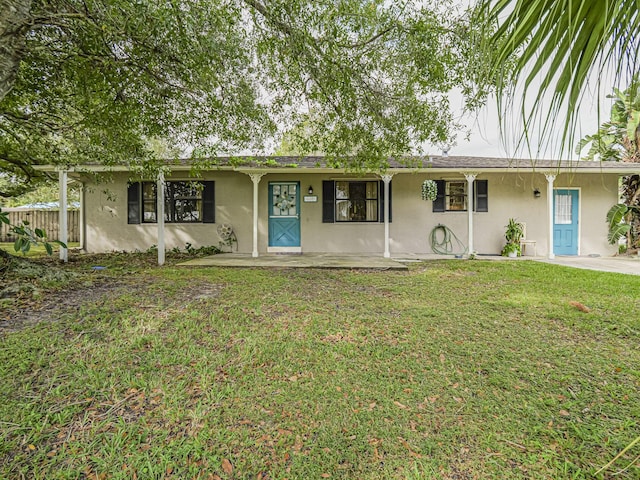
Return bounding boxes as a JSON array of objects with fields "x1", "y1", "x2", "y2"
[{"x1": 35, "y1": 155, "x2": 640, "y2": 175}]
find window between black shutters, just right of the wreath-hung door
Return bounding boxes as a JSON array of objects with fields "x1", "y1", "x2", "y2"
[{"x1": 335, "y1": 181, "x2": 379, "y2": 222}]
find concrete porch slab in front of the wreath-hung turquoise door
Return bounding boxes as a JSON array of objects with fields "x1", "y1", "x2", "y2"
[{"x1": 178, "y1": 253, "x2": 408, "y2": 270}]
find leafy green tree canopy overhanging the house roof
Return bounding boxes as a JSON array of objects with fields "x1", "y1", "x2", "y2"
[{"x1": 0, "y1": 0, "x2": 490, "y2": 197}]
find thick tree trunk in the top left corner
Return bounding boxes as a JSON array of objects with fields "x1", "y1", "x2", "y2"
[{"x1": 0, "y1": 0, "x2": 31, "y2": 102}]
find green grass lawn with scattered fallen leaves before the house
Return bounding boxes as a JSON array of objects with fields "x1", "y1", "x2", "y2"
[{"x1": 0, "y1": 255, "x2": 640, "y2": 479}]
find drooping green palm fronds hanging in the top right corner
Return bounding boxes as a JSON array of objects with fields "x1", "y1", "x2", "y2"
[{"x1": 477, "y1": 0, "x2": 640, "y2": 153}]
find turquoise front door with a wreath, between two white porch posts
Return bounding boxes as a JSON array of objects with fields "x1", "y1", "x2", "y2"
[{"x1": 269, "y1": 182, "x2": 300, "y2": 249}]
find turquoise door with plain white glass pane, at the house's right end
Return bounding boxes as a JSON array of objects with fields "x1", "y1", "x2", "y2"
[{"x1": 553, "y1": 189, "x2": 579, "y2": 255}]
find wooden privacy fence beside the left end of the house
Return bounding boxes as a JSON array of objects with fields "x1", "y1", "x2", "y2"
[{"x1": 0, "y1": 208, "x2": 80, "y2": 242}]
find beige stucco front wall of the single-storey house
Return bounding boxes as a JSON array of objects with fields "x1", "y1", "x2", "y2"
[{"x1": 84, "y1": 171, "x2": 618, "y2": 256}]
